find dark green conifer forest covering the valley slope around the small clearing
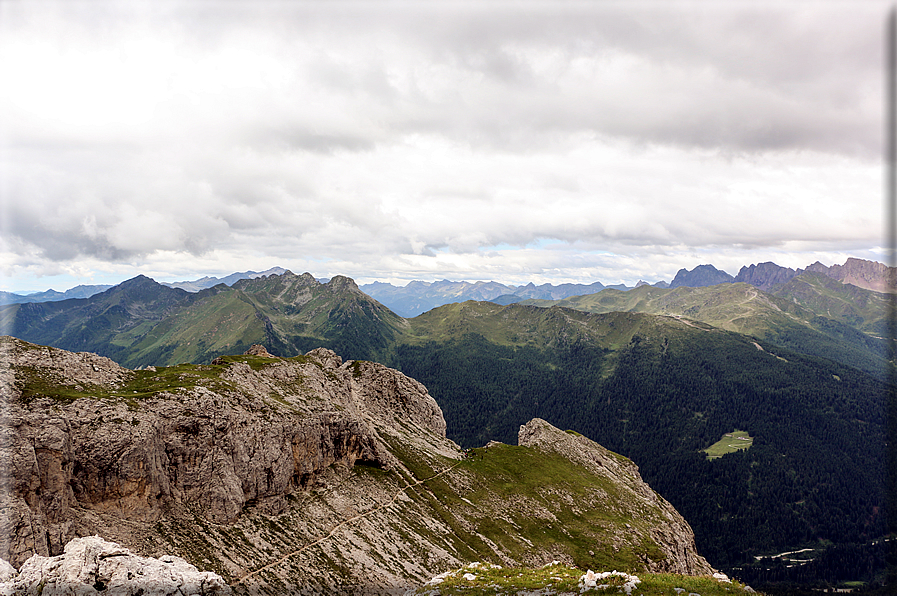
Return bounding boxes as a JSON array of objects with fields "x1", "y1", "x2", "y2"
[{"x1": 396, "y1": 332, "x2": 886, "y2": 583}]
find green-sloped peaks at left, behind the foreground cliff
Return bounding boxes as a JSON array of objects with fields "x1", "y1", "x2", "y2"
[{"x1": 0, "y1": 272, "x2": 405, "y2": 367}]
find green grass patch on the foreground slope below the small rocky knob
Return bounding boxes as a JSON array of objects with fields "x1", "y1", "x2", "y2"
[{"x1": 461, "y1": 445, "x2": 666, "y2": 571}]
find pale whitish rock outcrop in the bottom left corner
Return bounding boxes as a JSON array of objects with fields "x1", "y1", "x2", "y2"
[{"x1": 0, "y1": 536, "x2": 232, "y2": 596}]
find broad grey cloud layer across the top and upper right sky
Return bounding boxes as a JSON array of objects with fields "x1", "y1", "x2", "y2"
[{"x1": 24, "y1": 2, "x2": 883, "y2": 156}]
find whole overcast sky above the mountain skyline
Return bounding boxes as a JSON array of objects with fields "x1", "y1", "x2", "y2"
[{"x1": 0, "y1": 0, "x2": 890, "y2": 292}]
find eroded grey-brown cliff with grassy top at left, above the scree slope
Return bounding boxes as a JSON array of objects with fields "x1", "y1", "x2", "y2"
[{"x1": 0, "y1": 338, "x2": 445, "y2": 565}]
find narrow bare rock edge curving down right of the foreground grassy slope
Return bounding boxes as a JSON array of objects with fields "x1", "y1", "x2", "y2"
[{"x1": 517, "y1": 418, "x2": 713, "y2": 575}]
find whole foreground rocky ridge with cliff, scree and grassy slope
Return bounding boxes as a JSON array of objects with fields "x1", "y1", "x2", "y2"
[{"x1": 0, "y1": 337, "x2": 712, "y2": 594}]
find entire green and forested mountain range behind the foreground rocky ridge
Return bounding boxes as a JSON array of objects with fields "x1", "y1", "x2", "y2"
[{"x1": 0, "y1": 261, "x2": 889, "y2": 585}]
